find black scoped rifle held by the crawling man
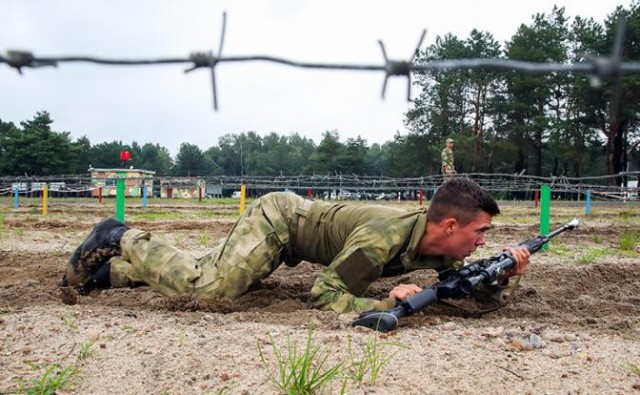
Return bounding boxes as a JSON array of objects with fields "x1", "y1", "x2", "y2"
[{"x1": 351, "y1": 218, "x2": 579, "y2": 332}]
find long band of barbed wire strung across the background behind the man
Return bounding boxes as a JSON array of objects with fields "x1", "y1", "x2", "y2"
[{"x1": 0, "y1": 171, "x2": 640, "y2": 200}]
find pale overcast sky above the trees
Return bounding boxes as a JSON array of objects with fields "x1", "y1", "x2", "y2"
[{"x1": 0, "y1": 0, "x2": 630, "y2": 155}]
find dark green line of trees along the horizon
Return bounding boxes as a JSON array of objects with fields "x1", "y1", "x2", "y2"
[{"x1": 0, "y1": 0, "x2": 640, "y2": 177}]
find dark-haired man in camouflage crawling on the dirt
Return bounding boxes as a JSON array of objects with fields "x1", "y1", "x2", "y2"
[{"x1": 61, "y1": 179, "x2": 530, "y2": 312}]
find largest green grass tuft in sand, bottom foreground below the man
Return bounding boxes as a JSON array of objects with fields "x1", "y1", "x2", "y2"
[{"x1": 257, "y1": 326, "x2": 345, "y2": 395}]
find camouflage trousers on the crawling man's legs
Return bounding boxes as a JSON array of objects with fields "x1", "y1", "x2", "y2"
[{"x1": 110, "y1": 192, "x2": 304, "y2": 299}]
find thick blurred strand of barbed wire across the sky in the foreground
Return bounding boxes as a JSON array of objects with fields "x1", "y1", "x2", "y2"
[{"x1": 0, "y1": 13, "x2": 640, "y2": 111}]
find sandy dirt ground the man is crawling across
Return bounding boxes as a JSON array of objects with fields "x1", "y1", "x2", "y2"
[{"x1": 0, "y1": 204, "x2": 640, "y2": 394}]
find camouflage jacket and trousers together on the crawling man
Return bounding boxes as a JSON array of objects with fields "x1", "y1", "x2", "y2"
[{"x1": 111, "y1": 192, "x2": 510, "y2": 312}]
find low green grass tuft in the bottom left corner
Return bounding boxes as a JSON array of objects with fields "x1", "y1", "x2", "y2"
[{"x1": 17, "y1": 362, "x2": 79, "y2": 395}]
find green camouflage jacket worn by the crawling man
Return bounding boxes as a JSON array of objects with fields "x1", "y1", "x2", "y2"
[{"x1": 298, "y1": 201, "x2": 462, "y2": 312}]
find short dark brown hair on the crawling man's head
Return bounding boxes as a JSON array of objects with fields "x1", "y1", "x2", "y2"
[{"x1": 427, "y1": 178, "x2": 500, "y2": 226}]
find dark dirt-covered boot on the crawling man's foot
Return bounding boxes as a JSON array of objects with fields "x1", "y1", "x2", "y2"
[{"x1": 60, "y1": 218, "x2": 129, "y2": 290}]
